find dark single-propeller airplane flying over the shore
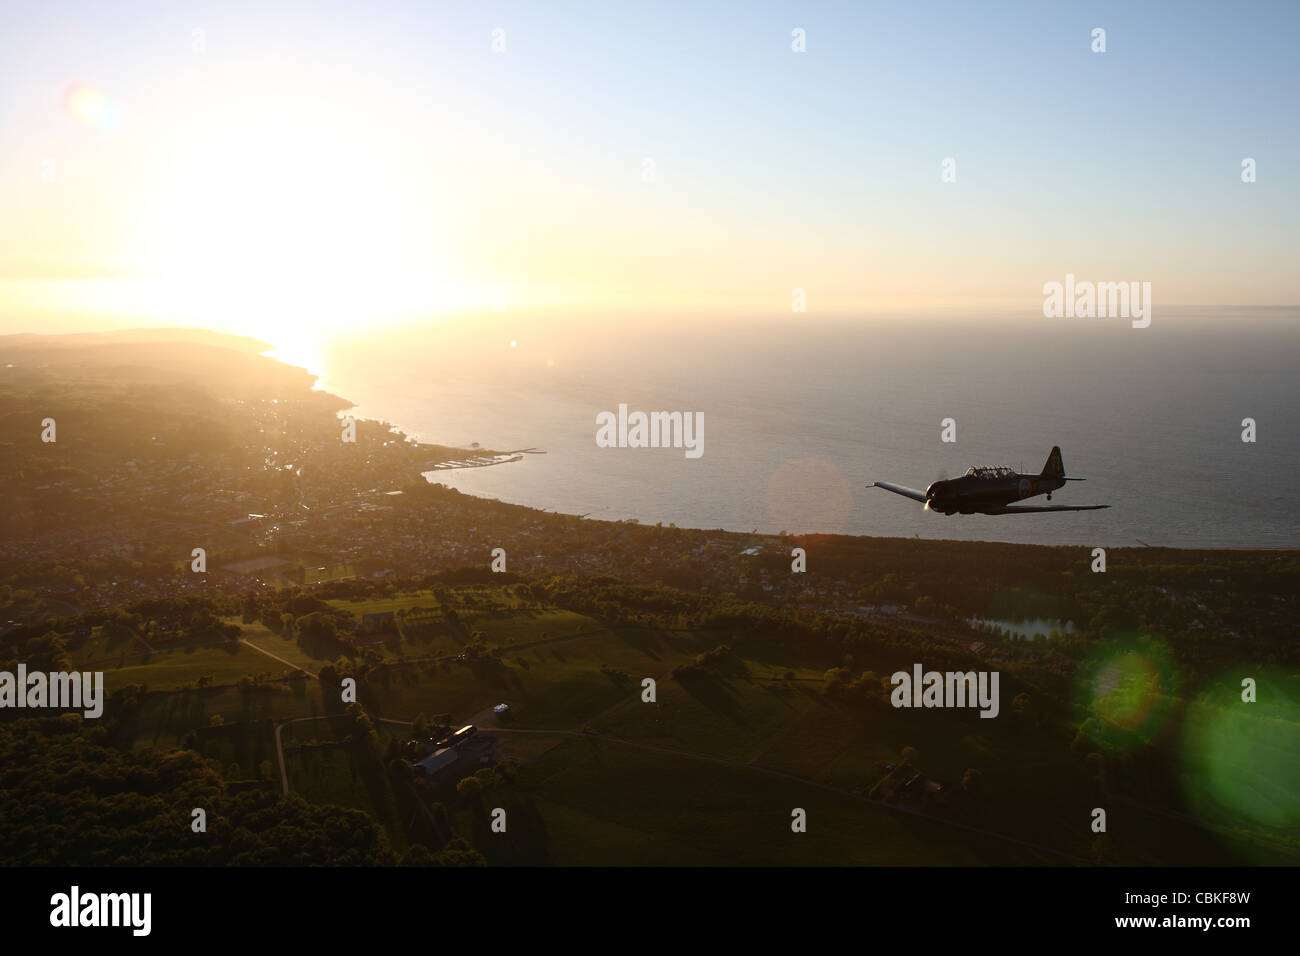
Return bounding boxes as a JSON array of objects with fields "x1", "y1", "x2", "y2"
[{"x1": 868, "y1": 445, "x2": 1110, "y2": 515}]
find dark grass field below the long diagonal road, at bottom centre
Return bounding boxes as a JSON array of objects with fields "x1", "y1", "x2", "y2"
[{"x1": 455, "y1": 740, "x2": 1040, "y2": 865}]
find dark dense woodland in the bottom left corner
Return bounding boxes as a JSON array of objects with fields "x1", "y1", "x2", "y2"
[{"x1": 0, "y1": 714, "x2": 397, "y2": 866}]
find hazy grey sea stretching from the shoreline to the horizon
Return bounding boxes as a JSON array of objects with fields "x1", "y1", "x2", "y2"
[{"x1": 312, "y1": 310, "x2": 1300, "y2": 548}]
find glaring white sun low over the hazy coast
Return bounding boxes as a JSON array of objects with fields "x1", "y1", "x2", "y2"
[{"x1": 125, "y1": 80, "x2": 459, "y2": 345}]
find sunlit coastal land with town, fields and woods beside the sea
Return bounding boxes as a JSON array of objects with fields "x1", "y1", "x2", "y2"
[{"x1": 0, "y1": 337, "x2": 1300, "y2": 865}]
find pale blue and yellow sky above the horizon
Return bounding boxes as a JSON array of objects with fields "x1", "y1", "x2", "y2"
[{"x1": 0, "y1": 0, "x2": 1300, "y2": 351}]
